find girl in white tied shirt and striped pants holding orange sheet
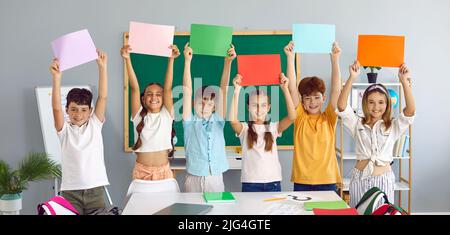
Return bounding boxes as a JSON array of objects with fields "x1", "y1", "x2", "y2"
[{"x1": 338, "y1": 61, "x2": 415, "y2": 207}]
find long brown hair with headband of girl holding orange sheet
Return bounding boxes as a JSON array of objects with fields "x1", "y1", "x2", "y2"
[{"x1": 362, "y1": 84, "x2": 392, "y2": 129}]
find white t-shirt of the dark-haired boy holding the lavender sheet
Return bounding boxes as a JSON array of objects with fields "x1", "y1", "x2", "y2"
[{"x1": 58, "y1": 113, "x2": 109, "y2": 190}]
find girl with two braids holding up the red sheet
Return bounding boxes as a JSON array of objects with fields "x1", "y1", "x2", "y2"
[{"x1": 229, "y1": 74, "x2": 296, "y2": 192}]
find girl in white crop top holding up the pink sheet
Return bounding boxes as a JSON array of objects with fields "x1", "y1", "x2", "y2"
[{"x1": 121, "y1": 45, "x2": 180, "y2": 180}]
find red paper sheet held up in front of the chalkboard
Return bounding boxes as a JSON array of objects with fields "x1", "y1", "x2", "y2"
[{"x1": 237, "y1": 54, "x2": 281, "y2": 86}]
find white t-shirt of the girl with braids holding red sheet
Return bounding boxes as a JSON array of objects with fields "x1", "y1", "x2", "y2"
[{"x1": 238, "y1": 122, "x2": 282, "y2": 183}]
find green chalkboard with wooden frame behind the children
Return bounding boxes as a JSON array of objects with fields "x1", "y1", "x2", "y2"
[{"x1": 124, "y1": 32, "x2": 293, "y2": 152}]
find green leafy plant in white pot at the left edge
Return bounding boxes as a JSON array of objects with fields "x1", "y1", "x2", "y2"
[{"x1": 0, "y1": 152, "x2": 61, "y2": 215}]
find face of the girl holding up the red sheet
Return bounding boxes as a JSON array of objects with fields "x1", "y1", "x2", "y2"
[{"x1": 248, "y1": 94, "x2": 270, "y2": 124}]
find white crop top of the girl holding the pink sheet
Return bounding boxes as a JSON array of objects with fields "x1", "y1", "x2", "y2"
[{"x1": 132, "y1": 106, "x2": 173, "y2": 152}]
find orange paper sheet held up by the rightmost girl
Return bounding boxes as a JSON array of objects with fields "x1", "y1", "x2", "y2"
[{"x1": 358, "y1": 35, "x2": 405, "y2": 67}]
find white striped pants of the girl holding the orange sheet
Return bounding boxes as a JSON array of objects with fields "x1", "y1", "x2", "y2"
[{"x1": 349, "y1": 168, "x2": 395, "y2": 208}]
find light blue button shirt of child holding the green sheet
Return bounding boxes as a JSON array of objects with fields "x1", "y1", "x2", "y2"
[{"x1": 183, "y1": 113, "x2": 228, "y2": 176}]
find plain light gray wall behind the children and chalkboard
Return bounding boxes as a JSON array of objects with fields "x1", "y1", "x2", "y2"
[{"x1": 0, "y1": 0, "x2": 450, "y2": 214}]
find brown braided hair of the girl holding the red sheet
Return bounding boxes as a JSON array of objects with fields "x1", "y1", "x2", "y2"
[{"x1": 247, "y1": 88, "x2": 274, "y2": 152}]
